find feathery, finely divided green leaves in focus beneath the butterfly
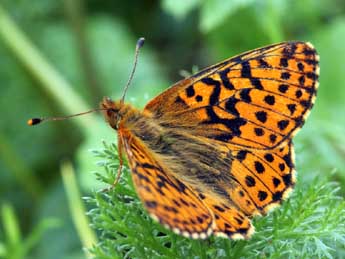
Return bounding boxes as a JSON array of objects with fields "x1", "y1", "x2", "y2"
[{"x1": 88, "y1": 143, "x2": 345, "y2": 259}]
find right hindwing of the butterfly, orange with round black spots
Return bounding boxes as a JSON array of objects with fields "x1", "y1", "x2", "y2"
[{"x1": 230, "y1": 142, "x2": 296, "y2": 215}]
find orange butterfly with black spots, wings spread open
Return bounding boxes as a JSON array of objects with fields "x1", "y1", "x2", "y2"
[{"x1": 28, "y1": 38, "x2": 319, "y2": 239}]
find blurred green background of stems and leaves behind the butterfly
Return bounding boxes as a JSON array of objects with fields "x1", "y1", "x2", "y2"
[{"x1": 0, "y1": 0, "x2": 345, "y2": 259}]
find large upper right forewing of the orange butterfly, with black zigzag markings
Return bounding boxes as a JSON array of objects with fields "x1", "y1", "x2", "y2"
[{"x1": 145, "y1": 42, "x2": 319, "y2": 149}]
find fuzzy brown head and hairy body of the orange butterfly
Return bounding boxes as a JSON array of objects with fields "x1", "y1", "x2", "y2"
[{"x1": 101, "y1": 99, "x2": 232, "y2": 201}]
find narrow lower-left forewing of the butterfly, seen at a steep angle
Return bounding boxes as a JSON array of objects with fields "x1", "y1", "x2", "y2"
[{"x1": 120, "y1": 131, "x2": 214, "y2": 238}]
